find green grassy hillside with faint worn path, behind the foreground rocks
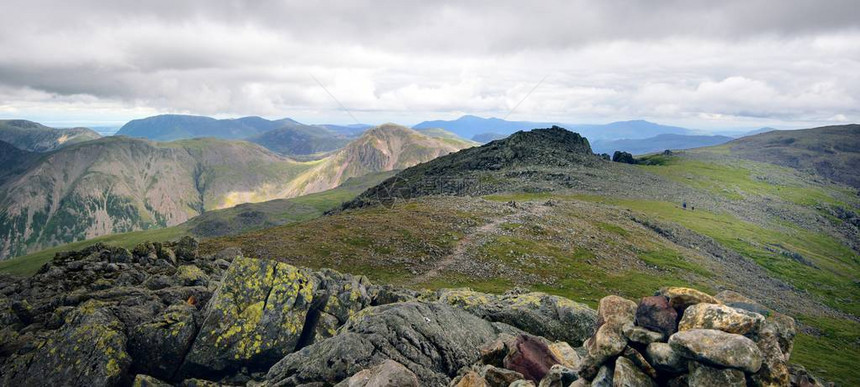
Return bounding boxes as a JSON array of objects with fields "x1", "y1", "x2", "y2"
[{"x1": 198, "y1": 127, "x2": 860, "y2": 385}]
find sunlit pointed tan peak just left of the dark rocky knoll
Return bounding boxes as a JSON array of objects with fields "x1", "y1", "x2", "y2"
[{"x1": 290, "y1": 124, "x2": 474, "y2": 196}]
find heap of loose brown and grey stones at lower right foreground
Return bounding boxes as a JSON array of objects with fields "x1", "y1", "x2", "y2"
[{"x1": 449, "y1": 287, "x2": 822, "y2": 387}]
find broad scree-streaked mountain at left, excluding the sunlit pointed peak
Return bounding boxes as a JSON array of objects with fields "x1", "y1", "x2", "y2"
[{"x1": 0, "y1": 137, "x2": 308, "y2": 258}]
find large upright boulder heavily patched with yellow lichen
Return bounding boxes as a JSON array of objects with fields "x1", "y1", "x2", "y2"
[{"x1": 183, "y1": 258, "x2": 317, "y2": 376}]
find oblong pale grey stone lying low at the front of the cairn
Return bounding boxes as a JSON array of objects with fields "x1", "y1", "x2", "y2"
[{"x1": 669, "y1": 329, "x2": 762, "y2": 373}]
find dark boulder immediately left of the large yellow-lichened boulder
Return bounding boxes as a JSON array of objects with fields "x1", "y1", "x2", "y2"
[{"x1": 128, "y1": 303, "x2": 197, "y2": 379}]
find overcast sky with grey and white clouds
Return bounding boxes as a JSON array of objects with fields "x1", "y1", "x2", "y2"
[{"x1": 0, "y1": 0, "x2": 860, "y2": 129}]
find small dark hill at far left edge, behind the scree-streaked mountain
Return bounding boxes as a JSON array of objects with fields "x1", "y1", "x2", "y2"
[{"x1": 0, "y1": 120, "x2": 101, "y2": 152}]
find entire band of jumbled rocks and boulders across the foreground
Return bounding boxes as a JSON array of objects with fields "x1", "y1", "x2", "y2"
[{"x1": 0, "y1": 241, "x2": 822, "y2": 387}]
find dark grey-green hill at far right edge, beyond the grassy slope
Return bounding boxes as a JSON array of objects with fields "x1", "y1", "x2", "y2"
[{"x1": 726, "y1": 124, "x2": 860, "y2": 188}]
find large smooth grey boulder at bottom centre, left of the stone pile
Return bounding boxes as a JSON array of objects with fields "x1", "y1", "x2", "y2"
[{"x1": 266, "y1": 302, "x2": 510, "y2": 386}]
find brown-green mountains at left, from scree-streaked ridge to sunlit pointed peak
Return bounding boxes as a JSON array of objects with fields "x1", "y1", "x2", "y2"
[{"x1": 0, "y1": 124, "x2": 473, "y2": 259}]
